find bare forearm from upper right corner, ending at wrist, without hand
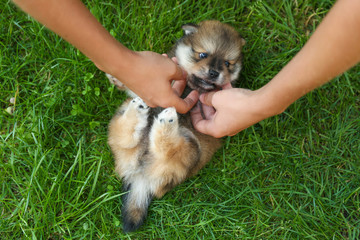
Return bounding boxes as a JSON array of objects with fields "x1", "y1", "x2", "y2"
[{"x1": 259, "y1": 0, "x2": 360, "y2": 114}]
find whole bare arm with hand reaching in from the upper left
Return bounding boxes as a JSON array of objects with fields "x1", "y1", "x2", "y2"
[{"x1": 14, "y1": 0, "x2": 197, "y2": 112}]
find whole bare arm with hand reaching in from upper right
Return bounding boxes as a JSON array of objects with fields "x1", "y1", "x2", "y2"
[{"x1": 192, "y1": 0, "x2": 360, "y2": 137}]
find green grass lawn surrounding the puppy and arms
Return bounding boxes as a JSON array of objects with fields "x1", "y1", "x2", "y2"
[{"x1": 0, "y1": 0, "x2": 360, "y2": 239}]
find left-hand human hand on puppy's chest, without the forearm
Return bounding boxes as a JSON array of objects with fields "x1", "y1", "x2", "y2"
[{"x1": 115, "y1": 51, "x2": 199, "y2": 113}]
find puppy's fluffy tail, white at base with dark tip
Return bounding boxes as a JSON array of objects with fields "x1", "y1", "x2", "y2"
[{"x1": 122, "y1": 181, "x2": 153, "y2": 232}]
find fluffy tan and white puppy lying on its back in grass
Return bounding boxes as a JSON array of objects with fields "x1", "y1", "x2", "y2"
[{"x1": 107, "y1": 21, "x2": 245, "y2": 232}]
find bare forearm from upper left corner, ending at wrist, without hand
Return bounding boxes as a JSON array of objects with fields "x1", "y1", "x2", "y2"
[{"x1": 13, "y1": 0, "x2": 134, "y2": 73}]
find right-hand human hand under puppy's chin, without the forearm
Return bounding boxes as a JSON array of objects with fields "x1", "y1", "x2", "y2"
[{"x1": 191, "y1": 84, "x2": 271, "y2": 138}]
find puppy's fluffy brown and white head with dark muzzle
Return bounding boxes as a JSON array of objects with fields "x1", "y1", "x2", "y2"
[{"x1": 175, "y1": 21, "x2": 245, "y2": 92}]
